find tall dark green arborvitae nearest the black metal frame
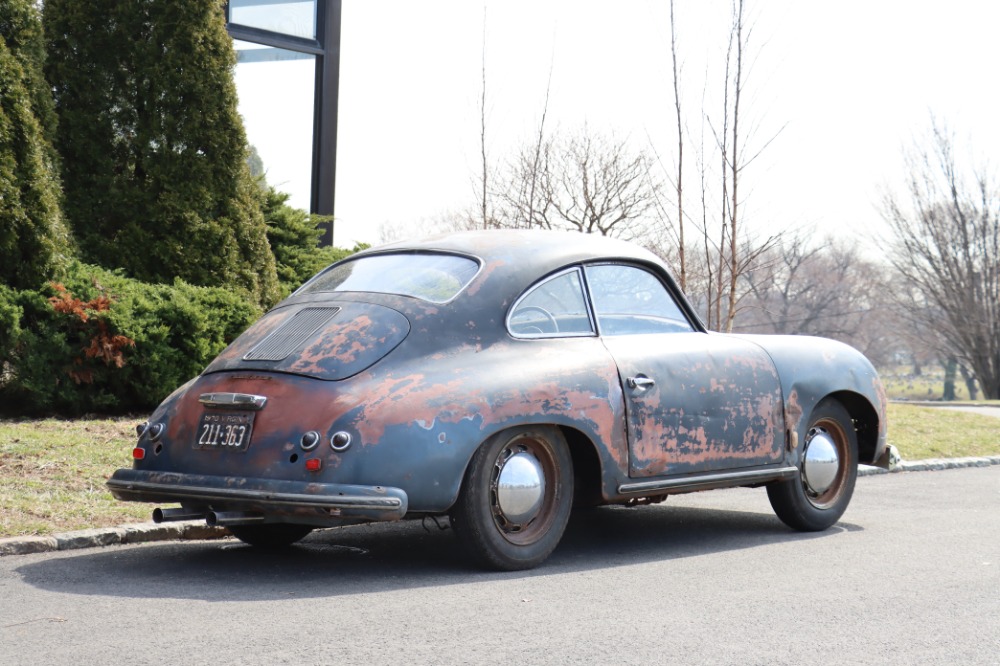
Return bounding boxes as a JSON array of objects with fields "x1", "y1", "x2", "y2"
[{"x1": 43, "y1": 0, "x2": 279, "y2": 305}]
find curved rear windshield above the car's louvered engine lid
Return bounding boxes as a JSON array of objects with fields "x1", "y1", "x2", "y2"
[{"x1": 299, "y1": 252, "x2": 479, "y2": 303}]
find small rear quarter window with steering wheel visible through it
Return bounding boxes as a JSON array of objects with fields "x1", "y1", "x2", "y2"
[{"x1": 507, "y1": 268, "x2": 594, "y2": 338}]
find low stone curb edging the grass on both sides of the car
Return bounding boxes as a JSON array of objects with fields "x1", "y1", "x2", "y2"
[{"x1": 0, "y1": 456, "x2": 1000, "y2": 556}]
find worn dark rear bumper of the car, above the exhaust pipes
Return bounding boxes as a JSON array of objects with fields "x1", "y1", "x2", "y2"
[{"x1": 108, "y1": 469, "x2": 407, "y2": 524}]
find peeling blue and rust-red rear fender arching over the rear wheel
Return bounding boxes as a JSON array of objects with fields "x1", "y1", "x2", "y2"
[{"x1": 340, "y1": 338, "x2": 628, "y2": 512}]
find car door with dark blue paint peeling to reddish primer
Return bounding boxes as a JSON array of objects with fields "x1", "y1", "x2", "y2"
[{"x1": 606, "y1": 333, "x2": 784, "y2": 477}]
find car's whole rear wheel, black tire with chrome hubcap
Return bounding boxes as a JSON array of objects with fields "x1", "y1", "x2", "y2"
[{"x1": 451, "y1": 426, "x2": 573, "y2": 571}]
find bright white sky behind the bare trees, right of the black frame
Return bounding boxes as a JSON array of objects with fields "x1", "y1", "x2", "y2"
[{"x1": 254, "y1": 0, "x2": 1000, "y2": 246}]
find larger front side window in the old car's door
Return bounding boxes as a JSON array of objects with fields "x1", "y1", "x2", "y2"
[{"x1": 587, "y1": 264, "x2": 694, "y2": 335}]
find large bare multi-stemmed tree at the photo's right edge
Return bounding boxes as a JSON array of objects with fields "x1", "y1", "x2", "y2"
[{"x1": 882, "y1": 122, "x2": 1000, "y2": 399}]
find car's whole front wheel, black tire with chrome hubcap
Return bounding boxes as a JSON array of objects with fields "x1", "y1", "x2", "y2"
[{"x1": 767, "y1": 399, "x2": 858, "y2": 532}]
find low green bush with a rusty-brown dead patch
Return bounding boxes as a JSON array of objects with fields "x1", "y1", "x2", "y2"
[{"x1": 0, "y1": 262, "x2": 260, "y2": 416}]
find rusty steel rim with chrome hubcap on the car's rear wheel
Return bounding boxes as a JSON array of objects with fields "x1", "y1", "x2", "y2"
[{"x1": 489, "y1": 436, "x2": 556, "y2": 545}]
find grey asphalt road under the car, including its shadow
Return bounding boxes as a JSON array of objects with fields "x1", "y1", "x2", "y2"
[{"x1": 0, "y1": 464, "x2": 1000, "y2": 666}]
